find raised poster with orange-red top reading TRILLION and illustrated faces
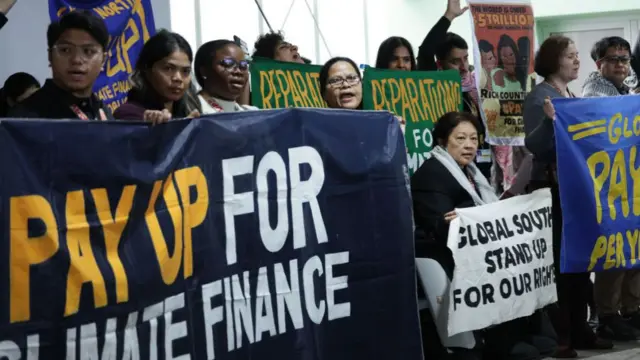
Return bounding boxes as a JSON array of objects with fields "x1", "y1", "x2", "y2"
[{"x1": 468, "y1": 0, "x2": 536, "y2": 146}]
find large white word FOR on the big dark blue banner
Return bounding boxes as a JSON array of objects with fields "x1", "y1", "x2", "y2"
[{"x1": 222, "y1": 146, "x2": 328, "y2": 265}]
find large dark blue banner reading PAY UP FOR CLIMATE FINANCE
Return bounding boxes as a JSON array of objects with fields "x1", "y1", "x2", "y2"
[{"x1": 0, "y1": 109, "x2": 422, "y2": 360}]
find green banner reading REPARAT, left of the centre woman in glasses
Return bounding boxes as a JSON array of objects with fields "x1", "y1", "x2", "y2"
[{"x1": 251, "y1": 58, "x2": 327, "y2": 109}]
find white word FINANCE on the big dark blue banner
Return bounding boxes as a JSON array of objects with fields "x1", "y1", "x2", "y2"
[{"x1": 202, "y1": 252, "x2": 351, "y2": 359}]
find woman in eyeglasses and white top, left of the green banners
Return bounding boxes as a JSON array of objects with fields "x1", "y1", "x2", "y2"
[{"x1": 194, "y1": 40, "x2": 258, "y2": 114}]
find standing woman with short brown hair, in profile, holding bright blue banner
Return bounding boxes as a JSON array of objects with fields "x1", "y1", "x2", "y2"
[{"x1": 523, "y1": 36, "x2": 613, "y2": 359}]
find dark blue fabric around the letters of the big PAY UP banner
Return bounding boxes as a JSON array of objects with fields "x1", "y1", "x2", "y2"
[{"x1": 0, "y1": 109, "x2": 422, "y2": 360}]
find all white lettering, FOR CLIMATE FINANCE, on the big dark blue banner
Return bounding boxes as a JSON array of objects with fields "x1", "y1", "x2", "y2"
[{"x1": 5, "y1": 146, "x2": 351, "y2": 360}]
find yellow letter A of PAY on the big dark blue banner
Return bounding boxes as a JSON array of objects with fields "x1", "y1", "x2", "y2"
[{"x1": 64, "y1": 190, "x2": 107, "y2": 316}]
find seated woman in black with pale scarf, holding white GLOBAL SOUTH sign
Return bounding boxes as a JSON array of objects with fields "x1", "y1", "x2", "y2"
[{"x1": 411, "y1": 112, "x2": 555, "y2": 359}]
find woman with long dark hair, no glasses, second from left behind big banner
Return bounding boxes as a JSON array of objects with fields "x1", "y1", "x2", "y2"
[{"x1": 113, "y1": 30, "x2": 200, "y2": 124}]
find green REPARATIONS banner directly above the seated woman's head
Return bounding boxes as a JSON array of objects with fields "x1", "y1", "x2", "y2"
[{"x1": 362, "y1": 68, "x2": 463, "y2": 174}]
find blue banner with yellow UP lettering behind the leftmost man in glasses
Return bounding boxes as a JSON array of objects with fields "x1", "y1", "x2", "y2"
[{"x1": 49, "y1": 0, "x2": 156, "y2": 111}]
